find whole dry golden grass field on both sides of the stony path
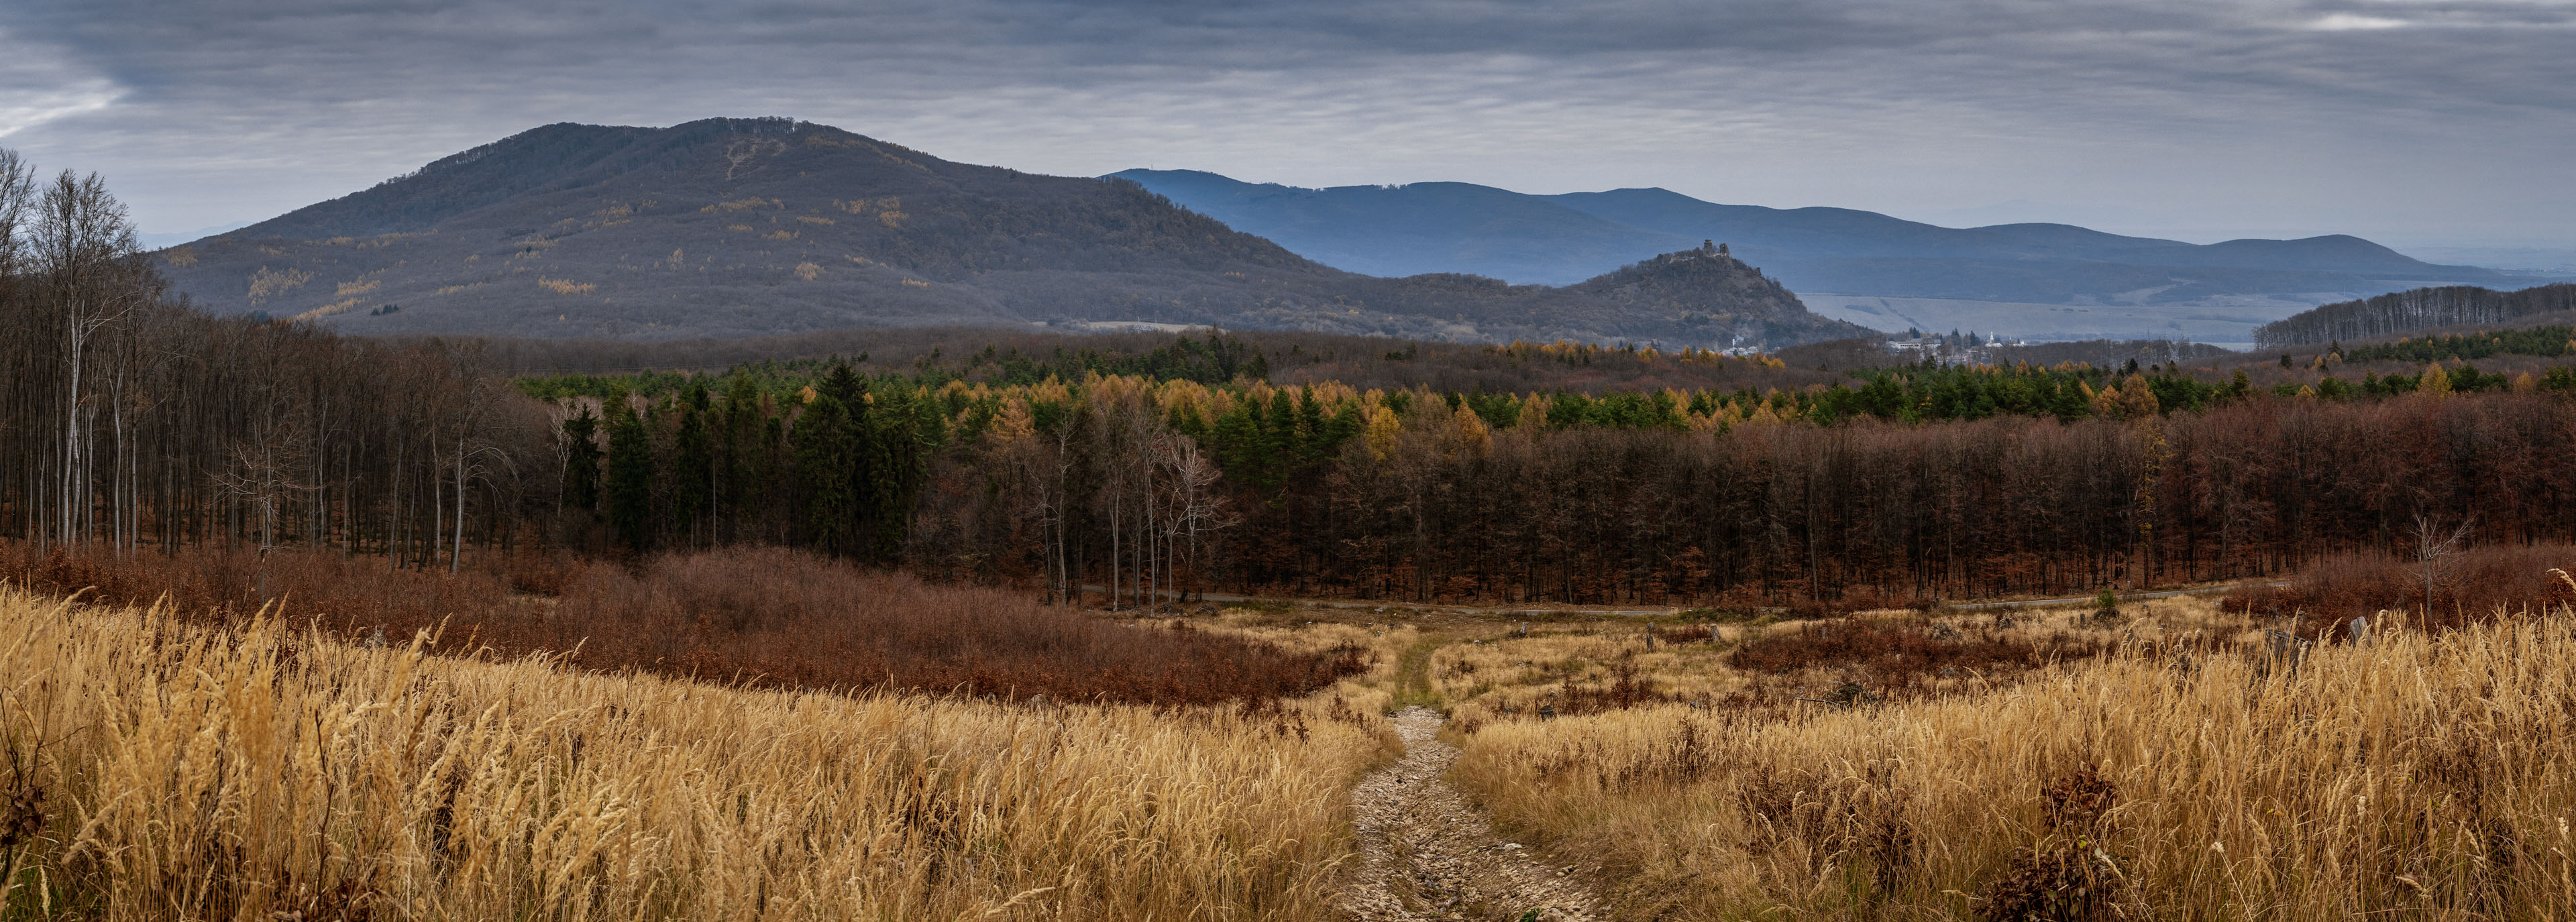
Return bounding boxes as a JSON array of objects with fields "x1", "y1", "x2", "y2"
[{"x1": 0, "y1": 551, "x2": 2576, "y2": 919}]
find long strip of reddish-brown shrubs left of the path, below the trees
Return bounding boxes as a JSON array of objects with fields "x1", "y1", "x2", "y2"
[{"x1": 0, "y1": 543, "x2": 1365, "y2": 705}]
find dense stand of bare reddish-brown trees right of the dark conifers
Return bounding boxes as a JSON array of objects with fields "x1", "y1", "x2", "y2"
[{"x1": 1179, "y1": 394, "x2": 2576, "y2": 603}]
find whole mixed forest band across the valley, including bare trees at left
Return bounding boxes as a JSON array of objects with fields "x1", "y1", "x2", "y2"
[{"x1": 0, "y1": 168, "x2": 2576, "y2": 620}]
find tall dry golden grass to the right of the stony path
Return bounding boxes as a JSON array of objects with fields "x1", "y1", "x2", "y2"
[{"x1": 1442, "y1": 600, "x2": 2576, "y2": 919}]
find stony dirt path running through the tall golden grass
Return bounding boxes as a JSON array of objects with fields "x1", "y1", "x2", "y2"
[{"x1": 1342, "y1": 705, "x2": 1607, "y2": 922}]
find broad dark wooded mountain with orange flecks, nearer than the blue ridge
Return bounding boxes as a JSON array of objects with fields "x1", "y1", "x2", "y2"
[{"x1": 160, "y1": 119, "x2": 1860, "y2": 345}]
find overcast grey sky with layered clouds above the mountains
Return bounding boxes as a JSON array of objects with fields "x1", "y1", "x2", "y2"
[{"x1": 0, "y1": 0, "x2": 2576, "y2": 247}]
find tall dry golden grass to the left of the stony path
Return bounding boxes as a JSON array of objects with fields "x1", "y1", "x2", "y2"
[{"x1": 0, "y1": 590, "x2": 1391, "y2": 919}]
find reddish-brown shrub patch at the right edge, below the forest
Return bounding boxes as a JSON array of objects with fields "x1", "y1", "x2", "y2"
[{"x1": 2220, "y1": 543, "x2": 2576, "y2": 641}]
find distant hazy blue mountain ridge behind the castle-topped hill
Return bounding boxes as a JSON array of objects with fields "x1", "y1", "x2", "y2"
[{"x1": 1113, "y1": 170, "x2": 2514, "y2": 304}]
